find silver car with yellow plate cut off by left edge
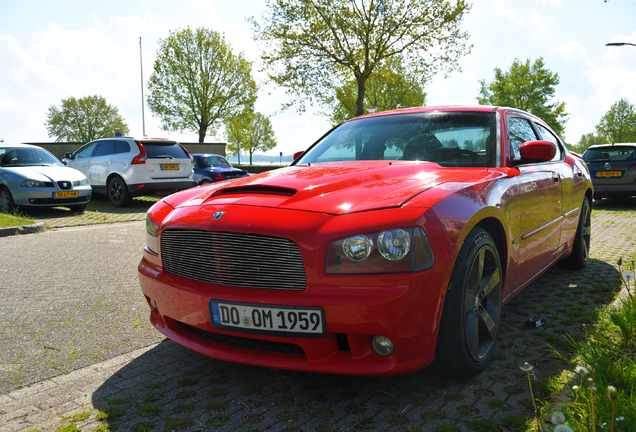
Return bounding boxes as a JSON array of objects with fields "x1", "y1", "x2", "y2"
[{"x1": 0, "y1": 143, "x2": 91, "y2": 213}]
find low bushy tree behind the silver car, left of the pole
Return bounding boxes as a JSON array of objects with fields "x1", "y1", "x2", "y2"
[{"x1": 44, "y1": 95, "x2": 130, "y2": 142}]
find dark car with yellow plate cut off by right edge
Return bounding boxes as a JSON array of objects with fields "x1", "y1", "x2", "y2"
[{"x1": 583, "y1": 144, "x2": 636, "y2": 199}]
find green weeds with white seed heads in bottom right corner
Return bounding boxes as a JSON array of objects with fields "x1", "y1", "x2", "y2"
[{"x1": 521, "y1": 259, "x2": 636, "y2": 432}]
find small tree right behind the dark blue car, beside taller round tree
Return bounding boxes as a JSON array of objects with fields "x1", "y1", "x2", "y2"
[{"x1": 225, "y1": 109, "x2": 276, "y2": 165}]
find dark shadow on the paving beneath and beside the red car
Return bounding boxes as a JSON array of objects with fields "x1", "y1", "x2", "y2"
[{"x1": 92, "y1": 259, "x2": 621, "y2": 430}]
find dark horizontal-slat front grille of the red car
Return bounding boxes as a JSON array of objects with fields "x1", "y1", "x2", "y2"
[{"x1": 161, "y1": 229, "x2": 307, "y2": 290}]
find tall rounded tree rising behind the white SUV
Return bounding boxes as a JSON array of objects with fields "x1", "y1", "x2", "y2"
[{"x1": 148, "y1": 28, "x2": 256, "y2": 143}]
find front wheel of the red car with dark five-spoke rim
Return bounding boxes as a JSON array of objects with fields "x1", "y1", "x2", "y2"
[{"x1": 433, "y1": 228, "x2": 503, "y2": 378}]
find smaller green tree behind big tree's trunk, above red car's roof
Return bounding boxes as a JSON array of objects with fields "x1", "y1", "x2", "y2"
[{"x1": 329, "y1": 57, "x2": 426, "y2": 126}]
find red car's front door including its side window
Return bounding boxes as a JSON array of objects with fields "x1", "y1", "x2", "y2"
[{"x1": 506, "y1": 113, "x2": 563, "y2": 285}]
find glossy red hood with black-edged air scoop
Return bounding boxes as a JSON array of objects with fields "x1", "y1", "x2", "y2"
[{"x1": 164, "y1": 162, "x2": 488, "y2": 214}]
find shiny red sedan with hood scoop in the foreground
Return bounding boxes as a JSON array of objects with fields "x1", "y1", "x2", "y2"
[{"x1": 139, "y1": 106, "x2": 593, "y2": 377}]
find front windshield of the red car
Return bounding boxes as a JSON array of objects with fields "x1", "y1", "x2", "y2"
[{"x1": 296, "y1": 111, "x2": 497, "y2": 167}]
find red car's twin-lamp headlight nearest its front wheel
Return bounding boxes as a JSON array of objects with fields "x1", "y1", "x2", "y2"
[{"x1": 325, "y1": 228, "x2": 434, "y2": 274}]
